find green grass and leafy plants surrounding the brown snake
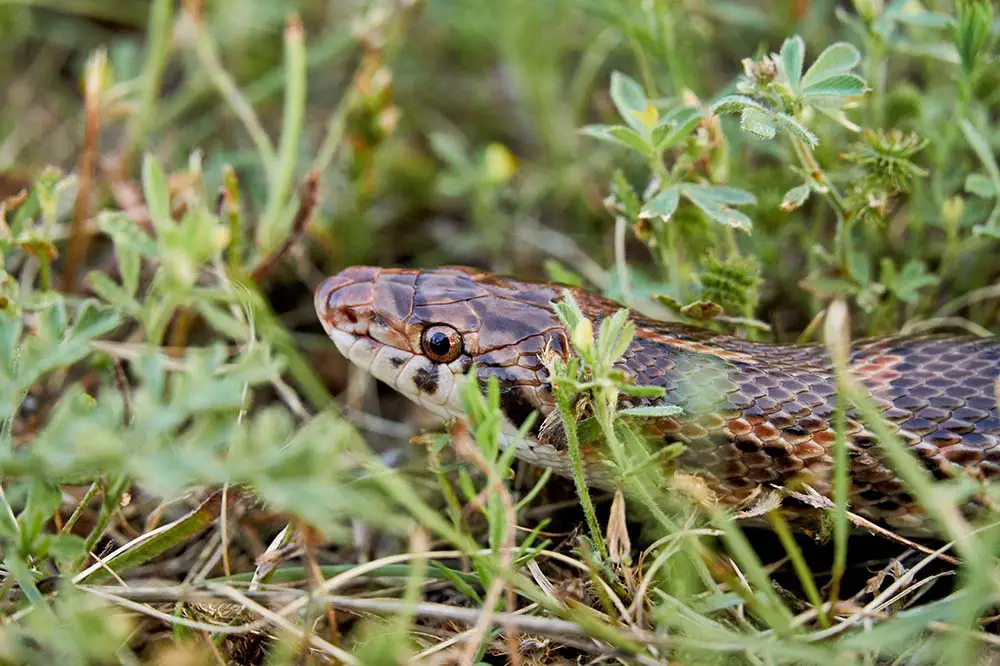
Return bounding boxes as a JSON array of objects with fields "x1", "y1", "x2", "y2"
[{"x1": 0, "y1": 0, "x2": 1000, "y2": 665}]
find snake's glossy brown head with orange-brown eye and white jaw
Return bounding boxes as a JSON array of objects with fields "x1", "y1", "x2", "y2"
[{"x1": 315, "y1": 266, "x2": 569, "y2": 426}]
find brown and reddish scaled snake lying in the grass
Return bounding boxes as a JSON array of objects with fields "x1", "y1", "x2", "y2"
[{"x1": 314, "y1": 266, "x2": 1000, "y2": 536}]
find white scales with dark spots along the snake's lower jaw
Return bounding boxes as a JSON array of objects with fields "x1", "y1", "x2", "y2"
[{"x1": 327, "y1": 327, "x2": 462, "y2": 418}]
